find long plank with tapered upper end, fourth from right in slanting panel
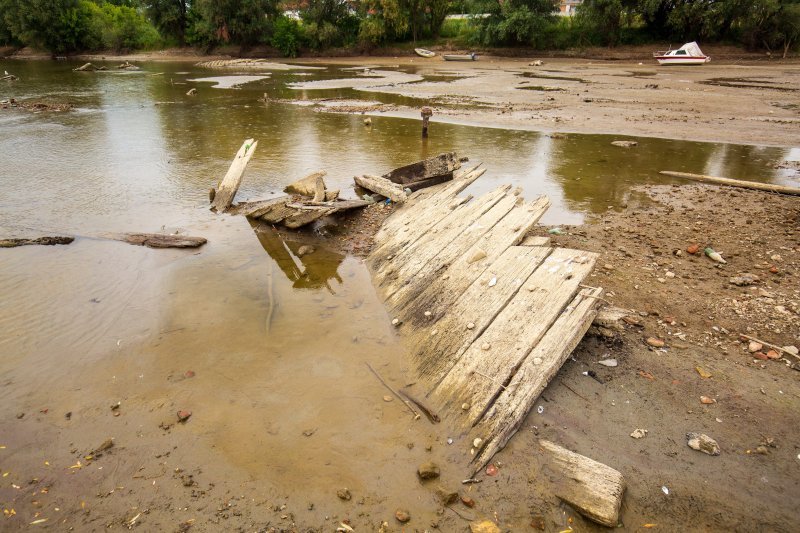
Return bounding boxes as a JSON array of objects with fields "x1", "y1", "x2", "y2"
[{"x1": 387, "y1": 196, "x2": 550, "y2": 316}]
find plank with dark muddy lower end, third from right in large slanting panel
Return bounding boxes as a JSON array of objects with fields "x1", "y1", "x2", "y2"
[{"x1": 410, "y1": 246, "x2": 552, "y2": 390}]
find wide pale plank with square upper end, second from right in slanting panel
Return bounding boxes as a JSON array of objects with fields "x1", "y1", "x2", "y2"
[{"x1": 433, "y1": 248, "x2": 597, "y2": 427}]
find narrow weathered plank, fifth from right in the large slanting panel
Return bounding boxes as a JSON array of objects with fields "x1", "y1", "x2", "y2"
[{"x1": 384, "y1": 191, "x2": 522, "y2": 305}]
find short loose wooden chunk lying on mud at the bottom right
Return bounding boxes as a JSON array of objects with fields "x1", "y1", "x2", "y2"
[{"x1": 539, "y1": 440, "x2": 625, "y2": 527}]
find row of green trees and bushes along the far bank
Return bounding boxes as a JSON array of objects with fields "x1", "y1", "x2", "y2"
[{"x1": 0, "y1": 0, "x2": 800, "y2": 56}]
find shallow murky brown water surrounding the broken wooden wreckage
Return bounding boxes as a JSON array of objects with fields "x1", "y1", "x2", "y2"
[{"x1": 0, "y1": 62, "x2": 800, "y2": 530}]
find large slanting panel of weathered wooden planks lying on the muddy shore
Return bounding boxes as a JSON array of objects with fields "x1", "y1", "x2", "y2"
[{"x1": 368, "y1": 167, "x2": 602, "y2": 472}]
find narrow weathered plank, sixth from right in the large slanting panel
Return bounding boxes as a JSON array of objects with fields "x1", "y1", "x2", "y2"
[{"x1": 374, "y1": 185, "x2": 511, "y2": 285}]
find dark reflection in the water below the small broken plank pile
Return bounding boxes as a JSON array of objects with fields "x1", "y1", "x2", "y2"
[{"x1": 254, "y1": 225, "x2": 345, "y2": 294}]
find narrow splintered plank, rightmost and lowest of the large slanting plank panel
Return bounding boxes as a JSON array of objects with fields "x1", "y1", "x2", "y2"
[{"x1": 470, "y1": 288, "x2": 603, "y2": 472}]
